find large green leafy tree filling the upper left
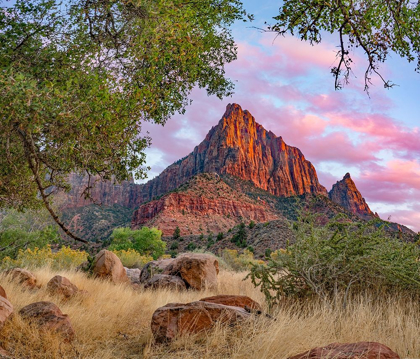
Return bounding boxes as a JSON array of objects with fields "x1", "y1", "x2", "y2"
[{"x1": 0, "y1": 0, "x2": 246, "y2": 242}]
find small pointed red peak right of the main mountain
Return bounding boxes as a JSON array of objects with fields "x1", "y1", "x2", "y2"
[{"x1": 328, "y1": 173, "x2": 375, "y2": 219}]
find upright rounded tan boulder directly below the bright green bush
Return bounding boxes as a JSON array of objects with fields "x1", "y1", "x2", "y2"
[{"x1": 93, "y1": 249, "x2": 129, "y2": 284}]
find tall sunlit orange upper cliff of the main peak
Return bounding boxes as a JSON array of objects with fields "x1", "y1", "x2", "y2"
[{"x1": 142, "y1": 104, "x2": 327, "y2": 201}]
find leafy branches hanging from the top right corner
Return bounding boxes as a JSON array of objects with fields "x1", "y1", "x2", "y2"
[{"x1": 268, "y1": 0, "x2": 420, "y2": 92}]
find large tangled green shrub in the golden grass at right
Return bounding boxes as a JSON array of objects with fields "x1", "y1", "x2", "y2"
[{"x1": 249, "y1": 215, "x2": 420, "y2": 304}]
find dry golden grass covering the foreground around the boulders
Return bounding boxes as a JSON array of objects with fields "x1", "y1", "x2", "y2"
[{"x1": 0, "y1": 269, "x2": 420, "y2": 359}]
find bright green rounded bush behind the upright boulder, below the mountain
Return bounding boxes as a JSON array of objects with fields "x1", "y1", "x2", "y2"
[{"x1": 109, "y1": 227, "x2": 166, "y2": 259}]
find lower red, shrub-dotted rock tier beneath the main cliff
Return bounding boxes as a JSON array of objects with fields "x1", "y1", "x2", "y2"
[{"x1": 131, "y1": 174, "x2": 281, "y2": 235}]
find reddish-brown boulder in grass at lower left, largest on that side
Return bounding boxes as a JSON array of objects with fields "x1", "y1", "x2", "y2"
[{"x1": 19, "y1": 302, "x2": 74, "y2": 342}]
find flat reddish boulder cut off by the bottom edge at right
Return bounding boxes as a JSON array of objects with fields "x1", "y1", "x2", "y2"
[{"x1": 289, "y1": 342, "x2": 400, "y2": 359}]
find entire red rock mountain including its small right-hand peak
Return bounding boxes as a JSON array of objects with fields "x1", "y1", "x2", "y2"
[{"x1": 62, "y1": 104, "x2": 402, "y2": 243}]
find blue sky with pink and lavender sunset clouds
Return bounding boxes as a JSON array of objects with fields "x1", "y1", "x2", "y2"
[{"x1": 139, "y1": 0, "x2": 420, "y2": 231}]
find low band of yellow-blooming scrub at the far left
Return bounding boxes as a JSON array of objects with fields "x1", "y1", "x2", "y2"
[{"x1": 0, "y1": 246, "x2": 88, "y2": 270}]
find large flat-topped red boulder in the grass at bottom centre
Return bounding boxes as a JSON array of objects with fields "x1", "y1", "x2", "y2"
[{"x1": 151, "y1": 301, "x2": 251, "y2": 343}]
